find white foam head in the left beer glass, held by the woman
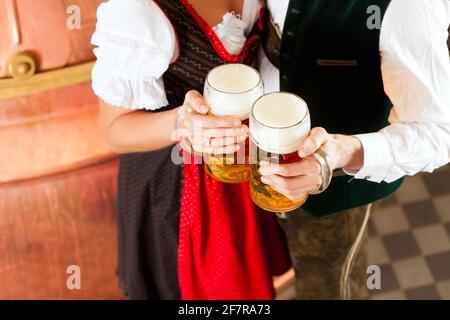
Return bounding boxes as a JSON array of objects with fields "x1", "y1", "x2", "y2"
[{"x1": 204, "y1": 64, "x2": 264, "y2": 119}]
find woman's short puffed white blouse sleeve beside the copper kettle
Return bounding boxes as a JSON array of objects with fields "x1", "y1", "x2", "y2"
[{"x1": 91, "y1": 0, "x2": 178, "y2": 110}]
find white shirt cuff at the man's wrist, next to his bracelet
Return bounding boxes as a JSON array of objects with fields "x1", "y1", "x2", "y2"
[{"x1": 344, "y1": 132, "x2": 393, "y2": 183}]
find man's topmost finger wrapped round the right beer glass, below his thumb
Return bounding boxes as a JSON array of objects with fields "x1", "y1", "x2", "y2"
[{"x1": 259, "y1": 157, "x2": 322, "y2": 177}]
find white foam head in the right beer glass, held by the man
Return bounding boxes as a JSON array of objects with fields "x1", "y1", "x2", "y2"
[{"x1": 250, "y1": 92, "x2": 311, "y2": 154}]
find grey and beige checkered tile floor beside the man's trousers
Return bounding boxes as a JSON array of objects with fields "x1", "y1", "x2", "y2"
[{"x1": 369, "y1": 167, "x2": 450, "y2": 300}]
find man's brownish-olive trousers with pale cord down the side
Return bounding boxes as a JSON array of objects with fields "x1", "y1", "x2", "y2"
[{"x1": 279, "y1": 205, "x2": 372, "y2": 300}]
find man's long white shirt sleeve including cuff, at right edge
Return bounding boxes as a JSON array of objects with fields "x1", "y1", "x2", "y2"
[{"x1": 355, "y1": 0, "x2": 450, "y2": 182}]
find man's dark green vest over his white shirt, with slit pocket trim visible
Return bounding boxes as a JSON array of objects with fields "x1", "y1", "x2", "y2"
[{"x1": 280, "y1": 0, "x2": 402, "y2": 216}]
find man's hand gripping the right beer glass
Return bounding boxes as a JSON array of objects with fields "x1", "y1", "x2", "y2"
[{"x1": 259, "y1": 128, "x2": 364, "y2": 200}]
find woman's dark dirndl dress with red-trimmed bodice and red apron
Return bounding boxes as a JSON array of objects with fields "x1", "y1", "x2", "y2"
[{"x1": 118, "y1": 0, "x2": 290, "y2": 299}]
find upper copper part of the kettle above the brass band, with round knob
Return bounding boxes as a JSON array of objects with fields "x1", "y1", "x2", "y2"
[{"x1": 0, "y1": 0, "x2": 104, "y2": 79}]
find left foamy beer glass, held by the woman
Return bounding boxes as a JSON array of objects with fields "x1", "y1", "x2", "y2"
[{"x1": 203, "y1": 64, "x2": 264, "y2": 183}]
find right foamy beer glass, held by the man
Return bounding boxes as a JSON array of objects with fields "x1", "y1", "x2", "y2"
[{"x1": 250, "y1": 92, "x2": 311, "y2": 213}]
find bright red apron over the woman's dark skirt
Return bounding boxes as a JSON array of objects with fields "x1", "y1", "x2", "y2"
[{"x1": 178, "y1": 154, "x2": 290, "y2": 300}]
